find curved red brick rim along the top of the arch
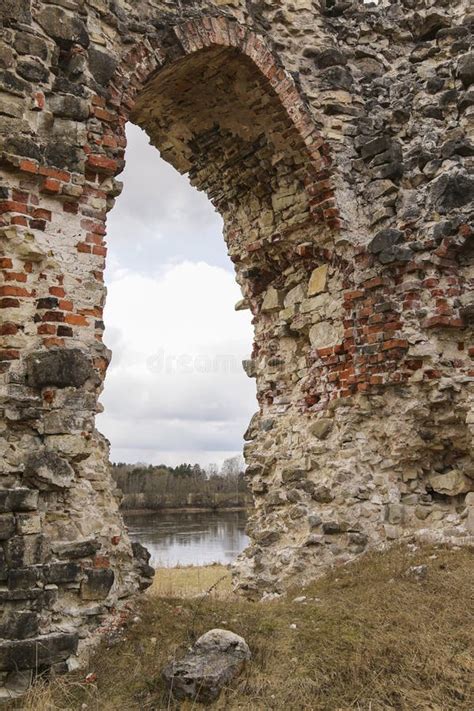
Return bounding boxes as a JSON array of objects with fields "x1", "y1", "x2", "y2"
[{"x1": 87, "y1": 16, "x2": 340, "y2": 229}]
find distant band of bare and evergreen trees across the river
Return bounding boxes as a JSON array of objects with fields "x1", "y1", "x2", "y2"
[{"x1": 112, "y1": 456, "x2": 252, "y2": 510}]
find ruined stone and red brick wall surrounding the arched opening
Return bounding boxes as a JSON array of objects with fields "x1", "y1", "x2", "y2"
[{"x1": 0, "y1": 0, "x2": 474, "y2": 697}]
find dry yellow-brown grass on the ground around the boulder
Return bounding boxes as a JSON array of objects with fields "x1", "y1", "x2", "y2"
[{"x1": 12, "y1": 548, "x2": 474, "y2": 711}]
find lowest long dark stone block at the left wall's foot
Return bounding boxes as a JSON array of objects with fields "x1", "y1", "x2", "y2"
[{"x1": 0, "y1": 632, "x2": 78, "y2": 671}]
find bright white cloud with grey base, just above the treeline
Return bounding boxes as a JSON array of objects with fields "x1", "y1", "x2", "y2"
[{"x1": 98, "y1": 262, "x2": 256, "y2": 463}]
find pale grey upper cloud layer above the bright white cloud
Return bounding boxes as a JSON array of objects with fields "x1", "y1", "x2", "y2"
[{"x1": 107, "y1": 124, "x2": 231, "y2": 275}]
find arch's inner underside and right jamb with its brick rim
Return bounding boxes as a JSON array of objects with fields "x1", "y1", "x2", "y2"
[{"x1": 94, "y1": 18, "x2": 340, "y2": 586}]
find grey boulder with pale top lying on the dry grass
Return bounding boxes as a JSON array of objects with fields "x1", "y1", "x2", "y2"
[{"x1": 163, "y1": 629, "x2": 251, "y2": 703}]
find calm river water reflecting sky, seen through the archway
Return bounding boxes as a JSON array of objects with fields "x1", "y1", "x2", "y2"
[{"x1": 124, "y1": 511, "x2": 248, "y2": 568}]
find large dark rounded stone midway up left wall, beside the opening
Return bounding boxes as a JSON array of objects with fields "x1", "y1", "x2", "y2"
[{"x1": 26, "y1": 348, "x2": 94, "y2": 390}]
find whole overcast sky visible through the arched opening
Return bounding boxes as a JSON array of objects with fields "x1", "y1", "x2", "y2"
[{"x1": 97, "y1": 125, "x2": 257, "y2": 465}]
